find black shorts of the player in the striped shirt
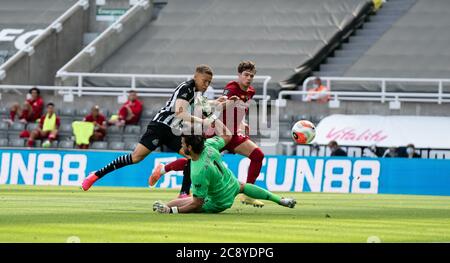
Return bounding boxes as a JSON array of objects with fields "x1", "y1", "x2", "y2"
[{"x1": 139, "y1": 121, "x2": 181, "y2": 153}]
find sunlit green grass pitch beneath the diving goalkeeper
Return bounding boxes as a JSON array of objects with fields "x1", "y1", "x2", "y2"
[{"x1": 0, "y1": 185, "x2": 450, "y2": 242}]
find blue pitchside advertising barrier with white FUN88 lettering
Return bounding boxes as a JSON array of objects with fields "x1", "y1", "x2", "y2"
[{"x1": 0, "y1": 149, "x2": 450, "y2": 196}]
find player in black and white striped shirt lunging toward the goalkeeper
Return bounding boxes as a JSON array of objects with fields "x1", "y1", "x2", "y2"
[{"x1": 81, "y1": 65, "x2": 218, "y2": 191}]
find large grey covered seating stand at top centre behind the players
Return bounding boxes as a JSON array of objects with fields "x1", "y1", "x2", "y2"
[{"x1": 72, "y1": 0, "x2": 373, "y2": 96}]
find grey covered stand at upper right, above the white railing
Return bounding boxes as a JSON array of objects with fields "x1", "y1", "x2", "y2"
[{"x1": 315, "y1": 0, "x2": 450, "y2": 93}]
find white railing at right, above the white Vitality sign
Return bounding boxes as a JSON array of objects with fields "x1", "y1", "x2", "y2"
[{"x1": 298, "y1": 77, "x2": 450, "y2": 106}]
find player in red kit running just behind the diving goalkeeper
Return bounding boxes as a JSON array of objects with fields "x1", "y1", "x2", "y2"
[{"x1": 149, "y1": 61, "x2": 264, "y2": 207}]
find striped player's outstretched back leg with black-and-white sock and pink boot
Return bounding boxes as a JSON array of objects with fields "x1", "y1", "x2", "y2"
[{"x1": 81, "y1": 143, "x2": 152, "y2": 191}]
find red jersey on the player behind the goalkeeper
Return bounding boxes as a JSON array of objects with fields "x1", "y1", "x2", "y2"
[{"x1": 220, "y1": 81, "x2": 255, "y2": 134}]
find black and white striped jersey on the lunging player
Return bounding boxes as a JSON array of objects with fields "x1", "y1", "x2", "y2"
[{"x1": 152, "y1": 79, "x2": 195, "y2": 126}]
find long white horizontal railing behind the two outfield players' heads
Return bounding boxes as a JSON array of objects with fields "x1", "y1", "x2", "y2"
[{"x1": 56, "y1": 71, "x2": 272, "y2": 121}]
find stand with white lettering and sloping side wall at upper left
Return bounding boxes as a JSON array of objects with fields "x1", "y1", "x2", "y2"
[{"x1": 0, "y1": 0, "x2": 89, "y2": 85}]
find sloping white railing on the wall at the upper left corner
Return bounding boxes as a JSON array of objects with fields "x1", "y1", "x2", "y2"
[{"x1": 0, "y1": 0, "x2": 89, "y2": 76}]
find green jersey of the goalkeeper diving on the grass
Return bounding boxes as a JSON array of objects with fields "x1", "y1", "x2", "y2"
[{"x1": 191, "y1": 136, "x2": 240, "y2": 208}]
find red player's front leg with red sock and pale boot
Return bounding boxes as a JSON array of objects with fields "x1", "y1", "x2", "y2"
[{"x1": 234, "y1": 140, "x2": 264, "y2": 207}]
